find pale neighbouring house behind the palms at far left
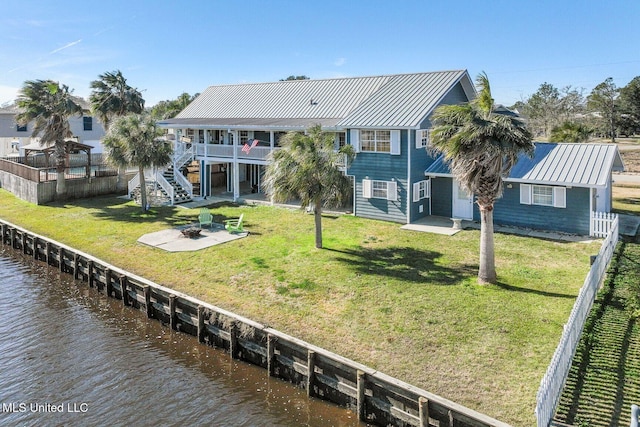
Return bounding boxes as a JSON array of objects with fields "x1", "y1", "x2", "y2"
[{"x1": 0, "y1": 100, "x2": 105, "y2": 157}]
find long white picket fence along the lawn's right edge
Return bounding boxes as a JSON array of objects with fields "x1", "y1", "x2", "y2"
[{"x1": 536, "y1": 216, "x2": 618, "y2": 427}]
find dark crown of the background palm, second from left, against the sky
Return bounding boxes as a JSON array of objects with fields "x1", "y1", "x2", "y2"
[{"x1": 89, "y1": 70, "x2": 144, "y2": 130}]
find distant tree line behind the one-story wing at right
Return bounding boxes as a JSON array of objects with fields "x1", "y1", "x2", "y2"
[{"x1": 510, "y1": 76, "x2": 640, "y2": 142}]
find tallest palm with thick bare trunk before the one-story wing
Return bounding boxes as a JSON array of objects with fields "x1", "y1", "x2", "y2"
[{"x1": 430, "y1": 73, "x2": 534, "y2": 283}]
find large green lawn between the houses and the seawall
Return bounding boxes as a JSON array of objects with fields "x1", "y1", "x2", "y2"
[{"x1": 0, "y1": 189, "x2": 600, "y2": 426}]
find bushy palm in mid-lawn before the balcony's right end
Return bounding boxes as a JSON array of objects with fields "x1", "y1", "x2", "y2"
[{"x1": 263, "y1": 125, "x2": 354, "y2": 249}]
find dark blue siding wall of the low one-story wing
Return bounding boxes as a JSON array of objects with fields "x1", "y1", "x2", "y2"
[{"x1": 488, "y1": 183, "x2": 590, "y2": 235}]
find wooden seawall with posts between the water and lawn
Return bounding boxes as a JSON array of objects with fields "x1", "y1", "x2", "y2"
[{"x1": 0, "y1": 220, "x2": 508, "y2": 427}]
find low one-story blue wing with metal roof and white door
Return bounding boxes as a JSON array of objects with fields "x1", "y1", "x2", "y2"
[{"x1": 424, "y1": 142, "x2": 624, "y2": 235}]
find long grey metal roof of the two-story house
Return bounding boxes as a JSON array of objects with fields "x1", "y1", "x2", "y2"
[{"x1": 158, "y1": 70, "x2": 475, "y2": 130}]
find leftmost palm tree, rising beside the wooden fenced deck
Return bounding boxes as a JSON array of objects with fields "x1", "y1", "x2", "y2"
[{"x1": 16, "y1": 80, "x2": 82, "y2": 198}]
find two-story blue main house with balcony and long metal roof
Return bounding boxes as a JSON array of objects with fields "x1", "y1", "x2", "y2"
[{"x1": 158, "y1": 70, "x2": 475, "y2": 223}]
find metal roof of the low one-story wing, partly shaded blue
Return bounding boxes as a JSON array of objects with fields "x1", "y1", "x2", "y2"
[{"x1": 425, "y1": 142, "x2": 624, "y2": 187}]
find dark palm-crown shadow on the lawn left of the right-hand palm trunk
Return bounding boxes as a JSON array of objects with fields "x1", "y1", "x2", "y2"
[{"x1": 327, "y1": 247, "x2": 478, "y2": 285}]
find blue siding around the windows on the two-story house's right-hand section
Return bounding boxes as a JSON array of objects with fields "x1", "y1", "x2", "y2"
[{"x1": 347, "y1": 130, "x2": 408, "y2": 223}]
